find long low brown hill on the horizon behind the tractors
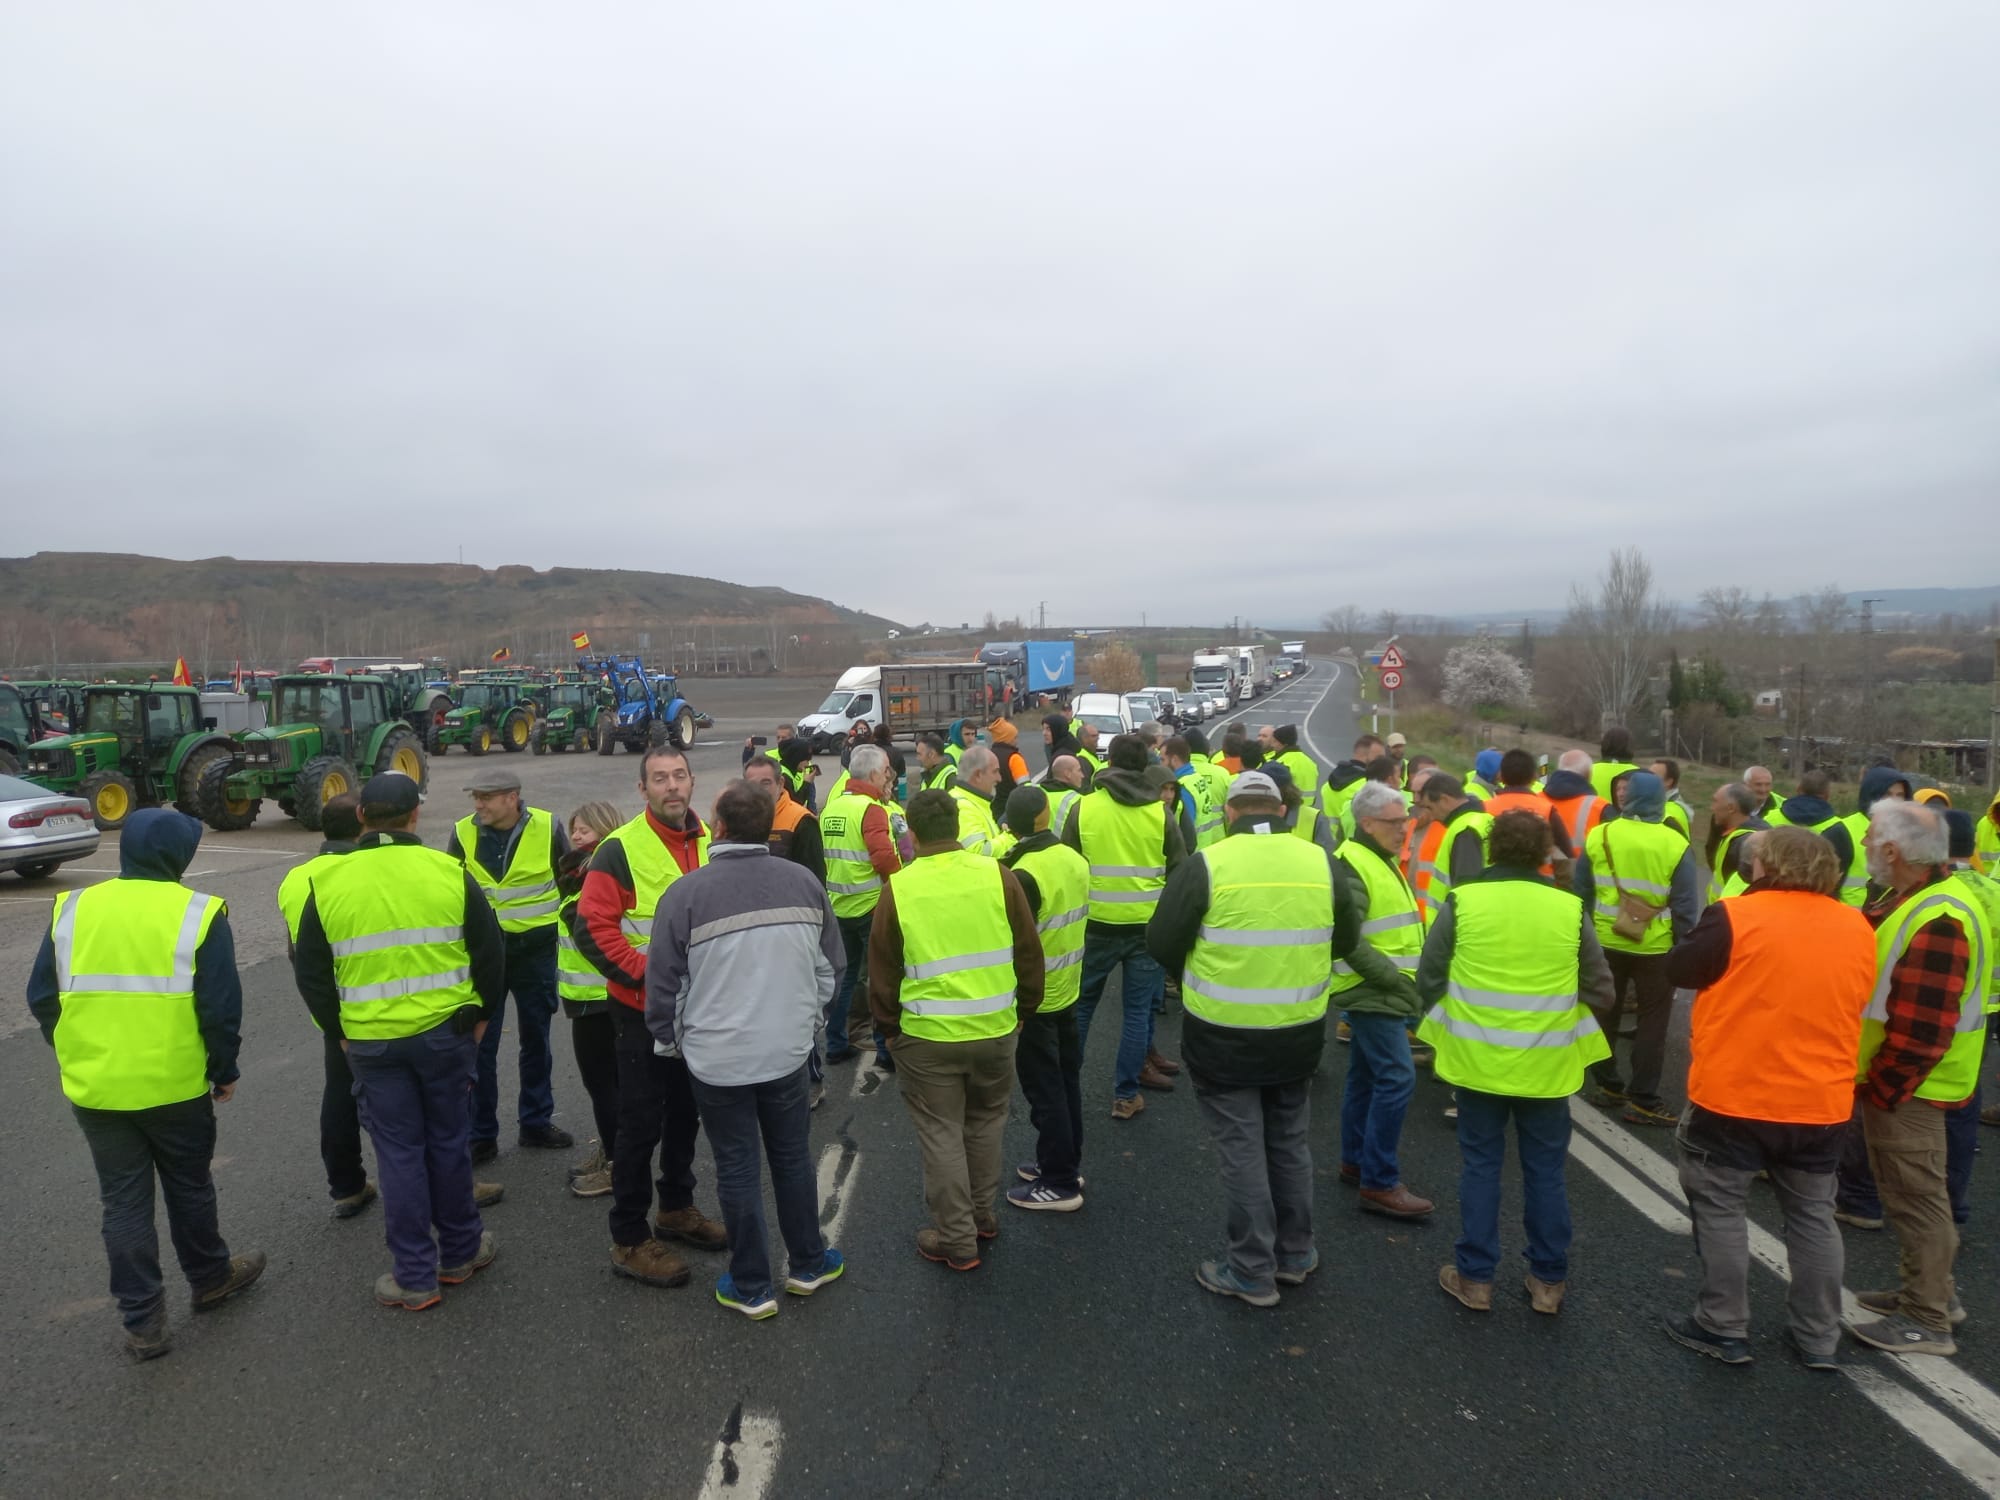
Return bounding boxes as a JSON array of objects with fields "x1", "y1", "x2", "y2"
[{"x1": 0, "y1": 552, "x2": 892, "y2": 672}]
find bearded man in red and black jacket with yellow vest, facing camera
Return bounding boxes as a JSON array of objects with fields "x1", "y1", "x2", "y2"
[{"x1": 570, "y1": 744, "x2": 728, "y2": 1286}]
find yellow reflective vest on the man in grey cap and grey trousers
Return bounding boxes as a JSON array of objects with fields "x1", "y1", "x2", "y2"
[{"x1": 1180, "y1": 834, "x2": 1334, "y2": 1030}]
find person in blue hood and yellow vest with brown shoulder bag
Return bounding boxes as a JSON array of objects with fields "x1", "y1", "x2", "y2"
[{"x1": 1570, "y1": 770, "x2": 1702, "y2": 1126}]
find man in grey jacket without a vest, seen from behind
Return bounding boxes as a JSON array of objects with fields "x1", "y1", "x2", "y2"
[{"x1": 646, "y1": 782, "x2": 846, "y2": 1318}]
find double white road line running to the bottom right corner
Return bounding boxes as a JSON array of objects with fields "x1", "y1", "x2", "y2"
[{"x1": 1570, "y1": 1098, "x2": 2000, "y2": 1496}]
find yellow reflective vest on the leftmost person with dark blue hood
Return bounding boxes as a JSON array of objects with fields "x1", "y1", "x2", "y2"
[{"x1": 50, "y1": 876, "x2": 226, "y2": 1110}]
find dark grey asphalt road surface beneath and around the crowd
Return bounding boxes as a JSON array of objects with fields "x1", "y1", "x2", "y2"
[{"x1": 11, "y1": 662, "x2": 2000, "y2": 1496}]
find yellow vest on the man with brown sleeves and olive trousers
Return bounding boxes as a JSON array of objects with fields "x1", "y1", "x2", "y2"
[{"x1": 890, "y1": 850, "x2": 1016, "y2": 1042}]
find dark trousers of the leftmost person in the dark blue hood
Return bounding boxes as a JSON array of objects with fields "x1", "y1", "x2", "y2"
[{"x1": 72, "y1": 1094, "x2": 230, "y2": 1328}]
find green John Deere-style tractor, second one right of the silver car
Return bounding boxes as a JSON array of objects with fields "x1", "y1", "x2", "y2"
[{"x1": 198, "y1": 672, "x2": 430, "y2": 832}]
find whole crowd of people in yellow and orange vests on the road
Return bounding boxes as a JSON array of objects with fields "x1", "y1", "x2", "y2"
[{"x1": 28, "y1": 712, "x2": 2000, "y2": 1368}]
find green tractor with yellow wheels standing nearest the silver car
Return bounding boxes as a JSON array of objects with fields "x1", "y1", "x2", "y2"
[{"x1": 22, "y1": 682, "x2": 236, "y2": 832}]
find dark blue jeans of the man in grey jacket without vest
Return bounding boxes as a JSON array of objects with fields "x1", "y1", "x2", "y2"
[{"x1": 690, "y1": 1066, "x2": 826, "y2": 1302}]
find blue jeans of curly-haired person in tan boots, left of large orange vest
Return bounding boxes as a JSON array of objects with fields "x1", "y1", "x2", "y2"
[{"x1": 1454, "y1": 1088, "x2": 1570, "y2": 1282}]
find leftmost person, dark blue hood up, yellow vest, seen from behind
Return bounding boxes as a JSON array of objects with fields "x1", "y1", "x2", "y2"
[{"x1": 28, "y1": 808, "x2": 264, "y2": 1360}]
